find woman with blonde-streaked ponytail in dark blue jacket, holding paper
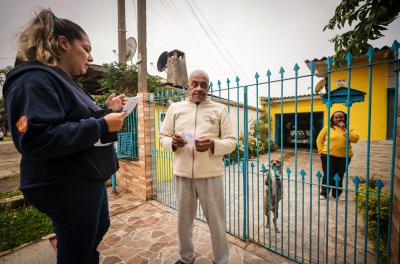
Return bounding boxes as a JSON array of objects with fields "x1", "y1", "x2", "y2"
[{"x1": 3, "y1": 9, "x2": 125, "y2": 263}]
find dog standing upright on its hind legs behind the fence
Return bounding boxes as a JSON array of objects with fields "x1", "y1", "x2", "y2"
[{"x1": 264, "y1": 160, "x2": 282, "y2": 233}]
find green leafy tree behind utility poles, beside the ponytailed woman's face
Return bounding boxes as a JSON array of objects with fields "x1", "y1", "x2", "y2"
[{"x1": 96, "y1": 62, "x2": 161, "y2": 102}]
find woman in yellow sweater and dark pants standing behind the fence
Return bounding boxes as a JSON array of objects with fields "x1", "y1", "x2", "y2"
[{"x1": 317, "y1": 111, "x2": 359, "y2": 199}]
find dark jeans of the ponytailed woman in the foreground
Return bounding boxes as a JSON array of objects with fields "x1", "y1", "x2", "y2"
[{"x1": 28, "y1": 183, "x2": 110, "y2": 264}]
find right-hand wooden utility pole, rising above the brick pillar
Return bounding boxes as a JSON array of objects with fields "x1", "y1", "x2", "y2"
[{"x1": 137, "y1": 0, "x2": 147, "y2": 93}]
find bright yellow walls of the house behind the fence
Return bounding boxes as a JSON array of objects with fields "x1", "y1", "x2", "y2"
[{"x1": 263, "y1": 61, "x2": 391, "y2": 140}]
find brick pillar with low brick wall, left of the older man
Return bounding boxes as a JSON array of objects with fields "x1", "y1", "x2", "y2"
[{"x1": 117, "y1": 93, "x2": 154, "y2": 200}]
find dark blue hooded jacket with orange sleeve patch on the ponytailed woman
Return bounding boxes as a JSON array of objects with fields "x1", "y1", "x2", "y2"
[{"x1": 3, "y1": 62, "x2": 118, "y2": 194}]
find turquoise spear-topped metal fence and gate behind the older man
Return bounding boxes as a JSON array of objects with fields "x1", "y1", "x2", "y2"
[{"x1": 149, "y1": 42, "x2": 399, "y2": 263}]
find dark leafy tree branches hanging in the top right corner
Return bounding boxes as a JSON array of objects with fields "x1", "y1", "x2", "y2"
[{"x1": 324, "y1": 0, "x2": 400, "y2": 66}]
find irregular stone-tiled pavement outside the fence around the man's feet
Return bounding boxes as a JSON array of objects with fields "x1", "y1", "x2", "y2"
[{"x1": 99, "y1": 188, "x2": 291, "y2": 264}]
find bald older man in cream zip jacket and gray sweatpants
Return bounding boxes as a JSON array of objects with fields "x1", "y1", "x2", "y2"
[{"x1": 160, "y1": 70, "x2": 236, "y2": 264}]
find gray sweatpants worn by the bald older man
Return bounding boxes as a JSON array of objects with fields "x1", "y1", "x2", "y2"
[{"x1": 175, "y1": 176, "x2": 229, "y2": 264}]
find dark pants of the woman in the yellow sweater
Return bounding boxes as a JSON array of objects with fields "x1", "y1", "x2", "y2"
[{"x1": 321, "y1": 154, "x2": 351, "y2": 198}]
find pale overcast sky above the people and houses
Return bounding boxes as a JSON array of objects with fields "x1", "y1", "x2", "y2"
[{"x1": 0, "y1": 0, "x2": 400, "y2": 102}]
